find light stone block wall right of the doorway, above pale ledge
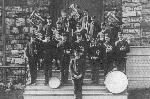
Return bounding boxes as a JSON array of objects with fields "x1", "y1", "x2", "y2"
[{"x1": 122, "y1": 0, "x2": 150, "y2": 46}]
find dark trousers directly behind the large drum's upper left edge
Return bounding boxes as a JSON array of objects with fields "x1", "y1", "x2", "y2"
[{"x1": 104, "y1": 61, "x2": 113, "y2": 76}]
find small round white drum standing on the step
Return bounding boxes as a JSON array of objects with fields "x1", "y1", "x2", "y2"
[{"x1": 49, "y1": 77, "x2": 60, "y2": 88}]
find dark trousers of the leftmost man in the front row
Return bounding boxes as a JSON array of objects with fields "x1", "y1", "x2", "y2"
[{"x1": 29, "y1": 57, "x2": 38, "y2": 83}]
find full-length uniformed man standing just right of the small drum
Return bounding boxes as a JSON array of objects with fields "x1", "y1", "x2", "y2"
[{"x1": 57, "y1": 33, "x2": 71, "y2": 85}]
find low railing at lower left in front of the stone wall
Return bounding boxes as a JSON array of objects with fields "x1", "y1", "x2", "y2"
[{"x1": 0, "y1": 66, "x2": 27, "y2": 85}]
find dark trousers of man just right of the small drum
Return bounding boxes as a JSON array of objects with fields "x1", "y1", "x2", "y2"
[{"x1": 60, "y1": 55, "x2": 70, "y2": 84}]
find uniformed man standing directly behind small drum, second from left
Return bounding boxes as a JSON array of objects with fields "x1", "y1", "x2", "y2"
[{"x1": 43, "y1": 35, "x2": 57, "y2": 85}]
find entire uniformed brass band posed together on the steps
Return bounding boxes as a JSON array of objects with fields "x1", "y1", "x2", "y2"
[{"x1": 26, "y1": 5, "x2": 130, "y2": 99}]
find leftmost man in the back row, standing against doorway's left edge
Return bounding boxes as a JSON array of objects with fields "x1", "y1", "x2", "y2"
[{"x1": 46, "y1": 16, "x2": 53, "y2": 40}]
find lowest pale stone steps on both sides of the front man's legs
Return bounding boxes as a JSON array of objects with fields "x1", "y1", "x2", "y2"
[{"x1": 23, "y1": 85, "x2": 128, "y2": 99}]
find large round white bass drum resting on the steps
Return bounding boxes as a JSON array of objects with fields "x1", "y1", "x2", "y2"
[{"x1": 104, "y1": 71, "x2": 128, "y2": 94}]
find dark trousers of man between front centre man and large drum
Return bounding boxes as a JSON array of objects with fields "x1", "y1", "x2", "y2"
[{"x1": 90, "y1": 59, "x2": 100, "y2": 83}]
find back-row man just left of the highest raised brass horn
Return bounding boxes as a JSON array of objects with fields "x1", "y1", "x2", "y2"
[{"x1": 57, "y1": 9, "x2": 68, "y2": 31}]
